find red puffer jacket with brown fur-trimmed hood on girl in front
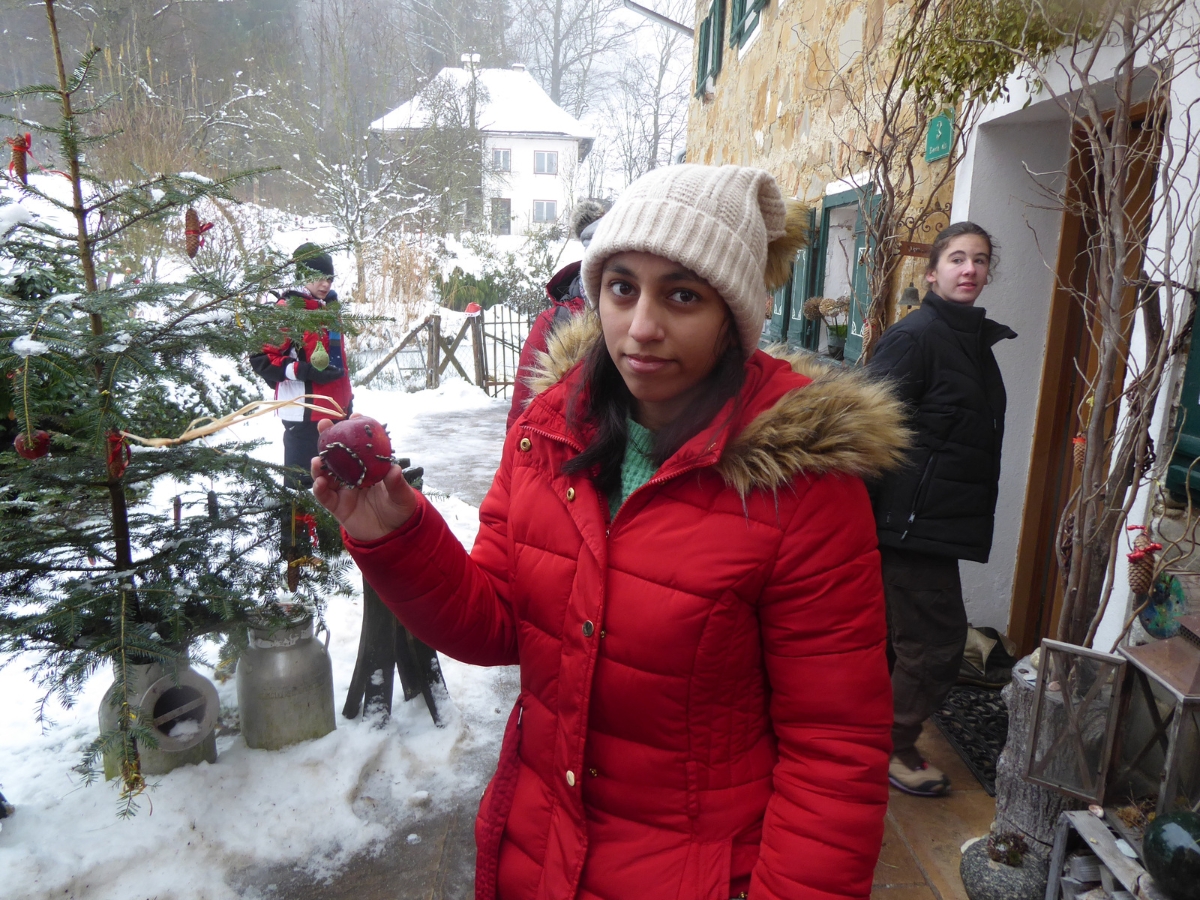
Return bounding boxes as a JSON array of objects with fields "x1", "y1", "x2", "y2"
[{"x1": 347, "y1": 317, "x2": 905, "y2": 900}]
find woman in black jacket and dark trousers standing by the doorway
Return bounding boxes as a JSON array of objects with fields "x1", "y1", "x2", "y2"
[{"x1": 869, "y1": 222, "x2": 1016, "y2": 797}]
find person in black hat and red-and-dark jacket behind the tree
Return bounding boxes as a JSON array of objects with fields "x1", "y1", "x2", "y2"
[{"x1": 250, "y1": 244, "x2": 354, "y2": 590}]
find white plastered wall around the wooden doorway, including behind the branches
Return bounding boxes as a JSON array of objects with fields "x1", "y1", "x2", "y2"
[{"x1": 953, "y1": 31, "x2": 1200, "y2": 650}]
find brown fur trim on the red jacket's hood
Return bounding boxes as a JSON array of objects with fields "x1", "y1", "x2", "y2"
[{"x1": 529, "y1": 310, "x2": 912, "y2": 497}]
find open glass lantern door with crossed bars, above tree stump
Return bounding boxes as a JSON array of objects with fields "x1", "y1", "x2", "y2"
[{"x1": 1024, "y1": 640, "x2": 1126, "y2": 804}]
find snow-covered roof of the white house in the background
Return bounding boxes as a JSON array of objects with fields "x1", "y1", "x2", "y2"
[{"x1": 371, "y1": 66, "x2": 594, "y2": 145}]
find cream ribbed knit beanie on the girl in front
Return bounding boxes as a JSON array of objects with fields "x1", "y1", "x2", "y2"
[{"x1": 582, "y1": 166, "x2": 787, "y2": 354}]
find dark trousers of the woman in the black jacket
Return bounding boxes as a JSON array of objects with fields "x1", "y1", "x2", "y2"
[{"x1": 880, "y1": 547, "x2": 967, "y2": 766}]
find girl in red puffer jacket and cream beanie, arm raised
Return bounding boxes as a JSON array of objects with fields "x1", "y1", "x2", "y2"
[{"x1": 313, "y1": 166, "x2": 906, "y2": 900}]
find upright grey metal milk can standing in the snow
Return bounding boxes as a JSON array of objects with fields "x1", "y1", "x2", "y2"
[{"x1": 238, "y1": 612, "x2": 337, "y2": 750}]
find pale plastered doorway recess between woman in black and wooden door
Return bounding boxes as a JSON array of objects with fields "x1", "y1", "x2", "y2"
[{"x1": 952, "y1": 101, "x2": 1068, "y2": 631}]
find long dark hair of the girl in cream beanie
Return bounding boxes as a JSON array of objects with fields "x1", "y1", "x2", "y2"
[{"x1": 563, "y1": 313, "x2": 746, "y2": 497}]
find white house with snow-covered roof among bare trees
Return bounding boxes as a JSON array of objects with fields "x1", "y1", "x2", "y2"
[{"x1": 371, "y1": 64, "x2": 595, "y2": 234}]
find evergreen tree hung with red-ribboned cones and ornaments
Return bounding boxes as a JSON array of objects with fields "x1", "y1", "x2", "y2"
[{"x1": 0, "y1": 0, "x2": 346, "y2": 814}]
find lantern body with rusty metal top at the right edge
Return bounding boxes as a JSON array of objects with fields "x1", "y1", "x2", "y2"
[{"x1": 1111, "y1": 616, "x2": 1200, "y2": 815}]
